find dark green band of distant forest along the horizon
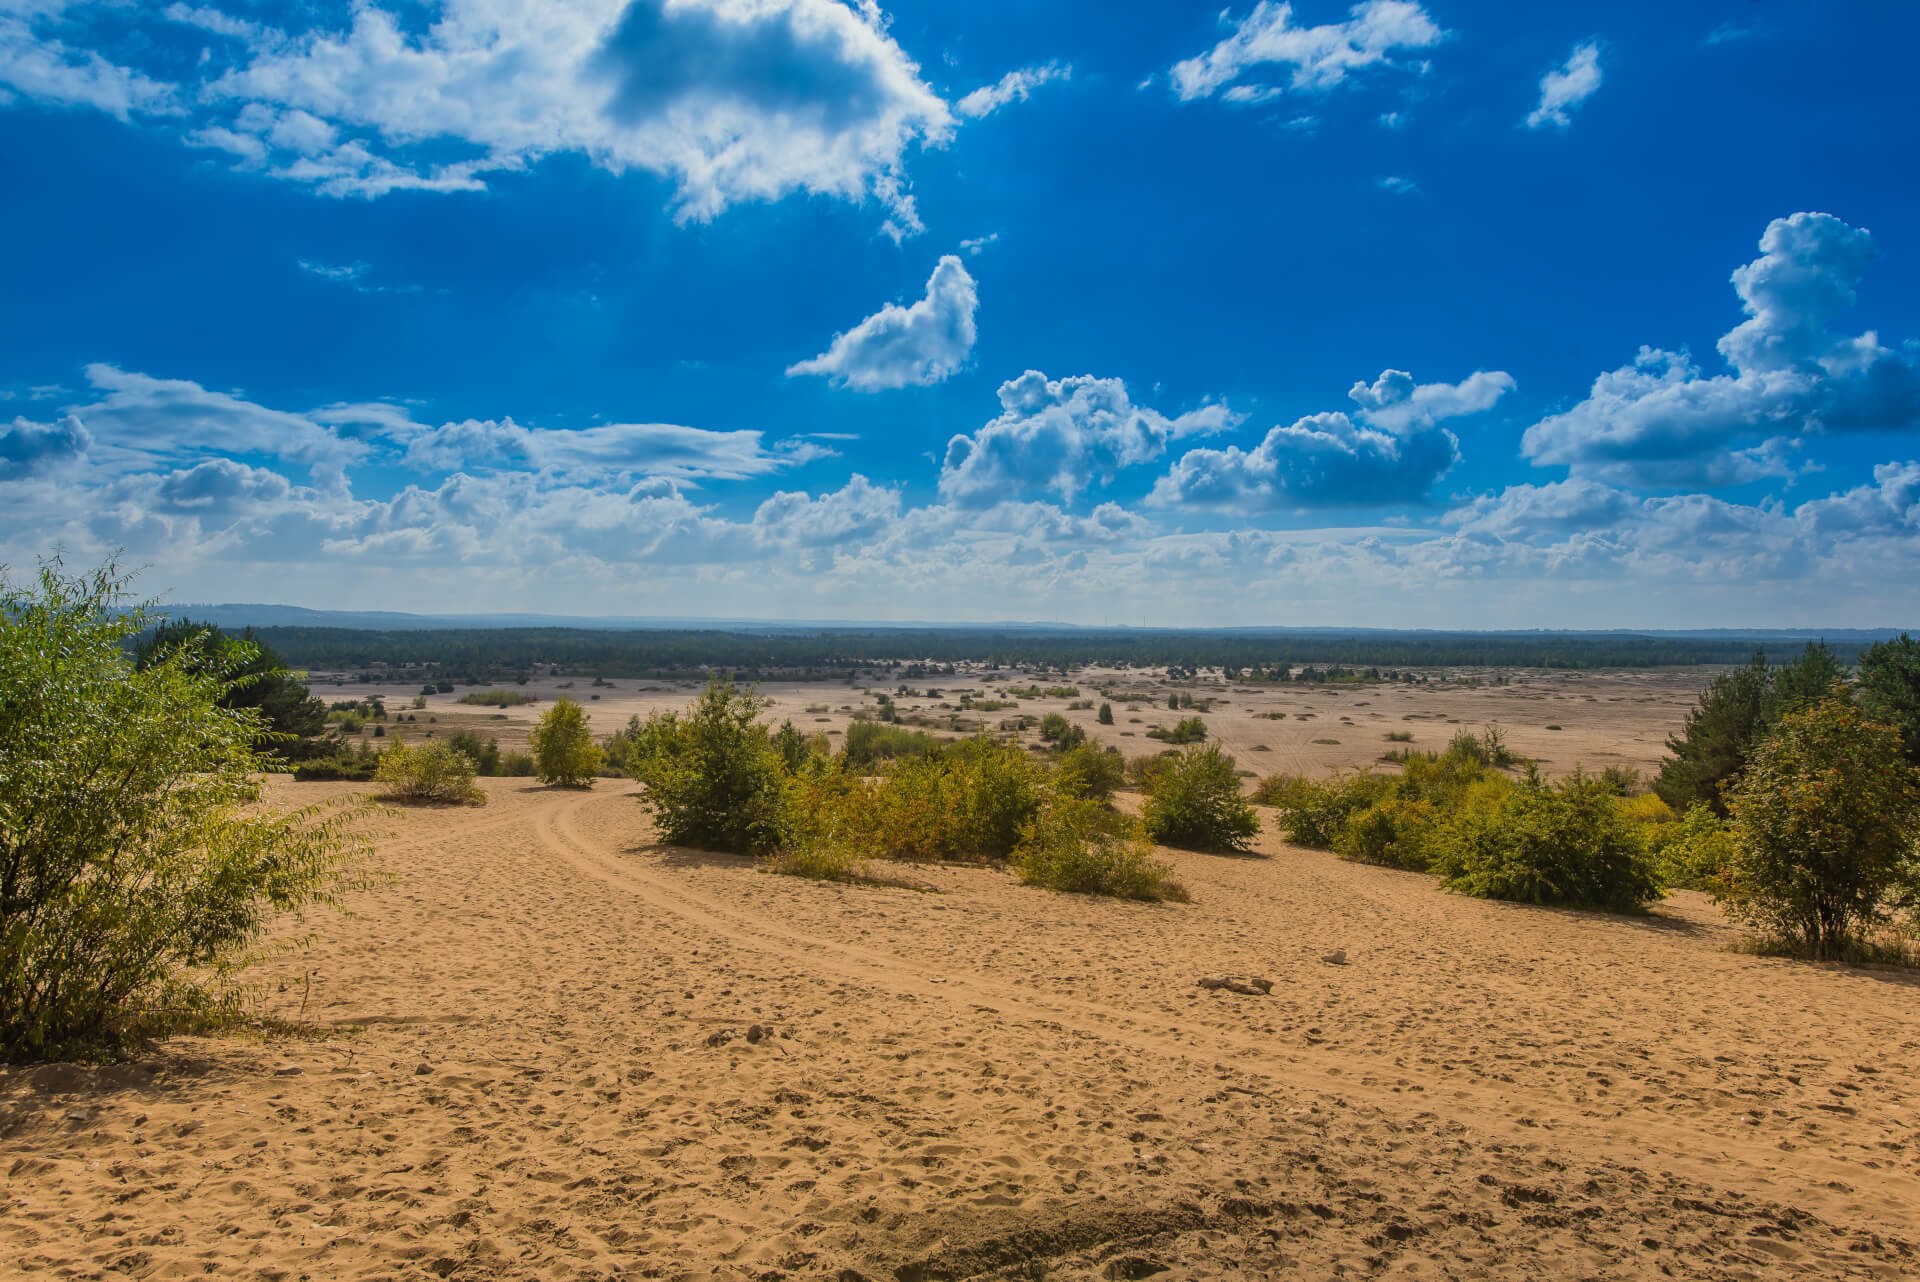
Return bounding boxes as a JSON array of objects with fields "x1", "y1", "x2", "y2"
[{"x1": 236, "y1": 628, "x2": 1860, "y2": 681}]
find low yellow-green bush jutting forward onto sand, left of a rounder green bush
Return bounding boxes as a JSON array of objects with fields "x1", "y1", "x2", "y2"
[{"x1": 1012, "y1": 795, "x2": 1188, "y2": 904}]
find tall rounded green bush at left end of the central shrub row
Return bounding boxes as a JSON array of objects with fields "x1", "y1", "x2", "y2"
[{"x1": 626, "y1": 677, "x2": 785, "y2": 854}]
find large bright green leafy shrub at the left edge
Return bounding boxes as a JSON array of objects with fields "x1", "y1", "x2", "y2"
[{"x1": 0, "y1": 560, "x2": 365, "y2": 1059}]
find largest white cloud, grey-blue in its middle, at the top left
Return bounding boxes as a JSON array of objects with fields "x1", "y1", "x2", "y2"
[{"x1": 0, "y1": 0, "x2": 960, "y2": 236}]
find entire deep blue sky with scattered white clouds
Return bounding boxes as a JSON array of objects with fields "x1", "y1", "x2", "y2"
[{"x1": 0, "y1": 0, "x2": 1920, "y2": 628}]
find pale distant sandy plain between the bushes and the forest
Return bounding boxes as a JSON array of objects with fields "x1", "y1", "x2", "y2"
[{"x1": 313, "y1": 668, "x2": 1713, "y2": 775}]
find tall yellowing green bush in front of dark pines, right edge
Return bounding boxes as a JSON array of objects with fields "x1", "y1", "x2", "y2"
[{"x1": 1718, "y1": 691, "x2": 1920, "y2": 958}]
